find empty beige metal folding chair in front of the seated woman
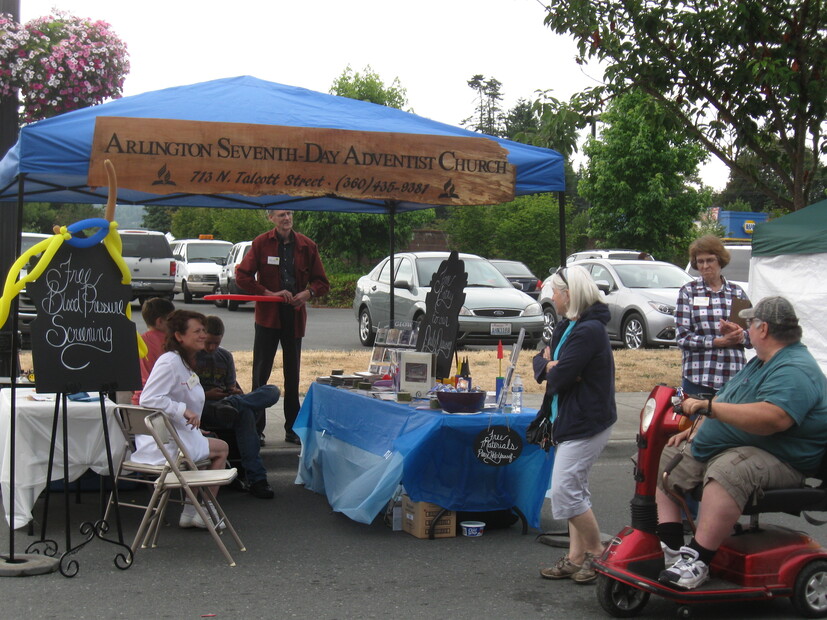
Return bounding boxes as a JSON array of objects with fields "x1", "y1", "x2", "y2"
[{"x1": 113, "y1": 406, "x2": 247, "y2": 566}]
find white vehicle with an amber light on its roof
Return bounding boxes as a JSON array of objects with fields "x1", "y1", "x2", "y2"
[{"x1": 170, "y1": 239, "x2": 233, "y2": 303}]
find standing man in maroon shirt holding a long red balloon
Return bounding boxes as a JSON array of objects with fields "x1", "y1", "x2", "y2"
[{"x1": 236, "y1": 209, "x2": 330, "y2": 444}]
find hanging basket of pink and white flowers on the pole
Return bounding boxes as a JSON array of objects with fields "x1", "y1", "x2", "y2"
[{"x1": 0, "y1": 11, "x2": 129, "y2": 121}]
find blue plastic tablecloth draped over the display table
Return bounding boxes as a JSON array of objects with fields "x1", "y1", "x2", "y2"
[{"x1": 293, "y1": 383, "x2": 554, "y2": 528}]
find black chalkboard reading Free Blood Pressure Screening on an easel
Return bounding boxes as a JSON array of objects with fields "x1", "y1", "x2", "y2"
[{"x1": 26, "y1": 242, "x2": 141, "y2": 393}]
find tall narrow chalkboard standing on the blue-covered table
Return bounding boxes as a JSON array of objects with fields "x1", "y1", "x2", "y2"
[{"x1": 416, "y1": 252, "x2": 468, "y2": 379}]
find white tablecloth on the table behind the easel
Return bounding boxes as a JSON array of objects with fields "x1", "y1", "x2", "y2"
[{"x1": 0, "y1": 388, "x2": 124, "y2": 529}]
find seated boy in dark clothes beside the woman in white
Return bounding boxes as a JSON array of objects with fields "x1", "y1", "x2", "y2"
[{"x1": 195, "y1": 316, "x2": 281, "y2": 499}]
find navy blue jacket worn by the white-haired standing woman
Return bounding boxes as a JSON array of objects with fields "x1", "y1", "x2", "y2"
[{"x1": 533, "y1": 302, "x2": 617, "y2": 443}]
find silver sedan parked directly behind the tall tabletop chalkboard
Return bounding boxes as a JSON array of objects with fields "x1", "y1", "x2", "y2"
[{"x1": 353, "y1": 252, "x2": 543, "y2": 348}]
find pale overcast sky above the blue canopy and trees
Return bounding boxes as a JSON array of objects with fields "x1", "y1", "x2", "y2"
[{"x1": 20, "y1": 0, "x2": 727, "y2": 189}]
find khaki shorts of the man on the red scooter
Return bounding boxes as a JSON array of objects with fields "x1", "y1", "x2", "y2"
[{"x1": 658, "y1": 442, "x2": 805, "y2": 510}]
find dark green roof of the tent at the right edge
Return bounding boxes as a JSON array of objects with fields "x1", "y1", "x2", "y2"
[{"x1": 752, "y1": 200, "x2": 827, "y2": 256}]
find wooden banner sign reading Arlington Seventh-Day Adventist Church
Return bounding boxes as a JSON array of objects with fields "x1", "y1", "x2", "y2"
[{"x1": 88, "y1": 116, "x2": 515, "y2": 205}]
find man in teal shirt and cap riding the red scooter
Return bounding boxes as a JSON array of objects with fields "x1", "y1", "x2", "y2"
[{"x1": 656, "y1": 297, "x2": 827, "y2": 589}]
